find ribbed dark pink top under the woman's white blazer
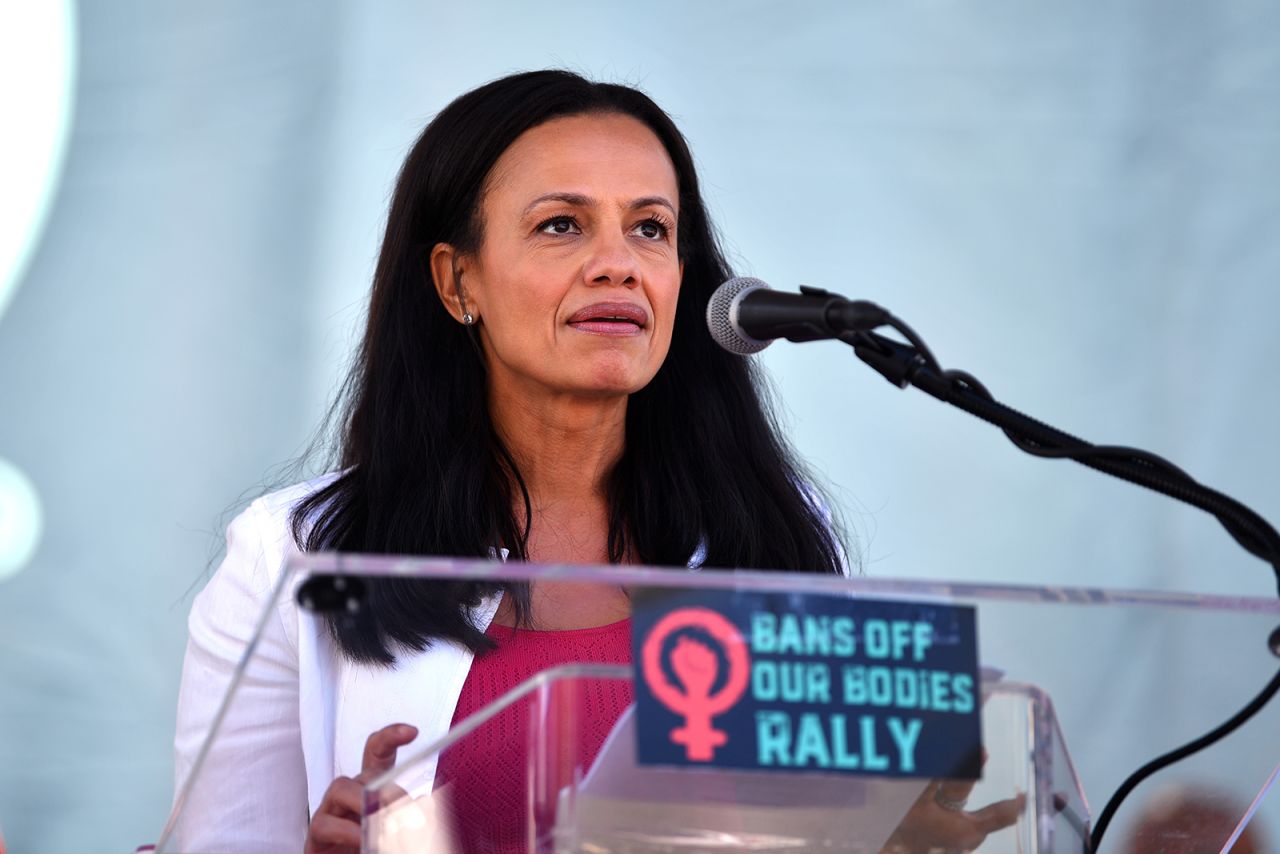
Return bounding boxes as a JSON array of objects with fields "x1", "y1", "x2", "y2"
[{"x1": 435, "y1": 620, "x2": 632, "y2": 854}]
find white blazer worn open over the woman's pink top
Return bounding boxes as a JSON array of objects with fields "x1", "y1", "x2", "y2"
[{"x1": 167, "y1": 475, "x2": 705, "y2": 854}]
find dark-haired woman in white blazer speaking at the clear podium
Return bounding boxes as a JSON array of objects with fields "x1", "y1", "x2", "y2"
[{"x1": 177, "y1": 70, "x2": 1008, "y2": 851}]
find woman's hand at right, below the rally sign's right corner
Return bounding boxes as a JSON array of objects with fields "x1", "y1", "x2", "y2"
[{"x1": 881, "y1": 780, "x2": 1027, "y2": 854}]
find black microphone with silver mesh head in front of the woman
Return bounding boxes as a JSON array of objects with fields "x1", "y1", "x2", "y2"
[{"x1": 707, "y1": 278, "x2": 891, "y2": 356}]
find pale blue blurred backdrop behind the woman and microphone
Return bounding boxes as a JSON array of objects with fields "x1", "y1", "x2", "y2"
[{"x1": 0, "y1": 0, "x2": 1280, "y2": 853}]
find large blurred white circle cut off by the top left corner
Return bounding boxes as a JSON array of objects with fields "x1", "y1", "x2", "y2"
[{"x1": 0, "y1": 0, "x2": 76, "y2": 316}]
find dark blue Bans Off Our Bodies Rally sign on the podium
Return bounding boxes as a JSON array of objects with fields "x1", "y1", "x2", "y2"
[{"x1": 632, "y1": 589, "x2": 982, "y2": 780}]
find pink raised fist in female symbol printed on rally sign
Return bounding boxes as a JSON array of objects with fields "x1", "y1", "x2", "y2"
[{"x1": 640, "y1": 608, "x2": 751, "y2": 762}]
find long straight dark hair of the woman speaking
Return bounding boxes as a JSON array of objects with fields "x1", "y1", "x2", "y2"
[{"x1": 291, "y1": 70, "x2": 841, "y2": 663}]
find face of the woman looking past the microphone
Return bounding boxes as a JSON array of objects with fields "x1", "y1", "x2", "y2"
[{"x1": 438, "y1": 114, "x2": 682, "y2": 399}]
